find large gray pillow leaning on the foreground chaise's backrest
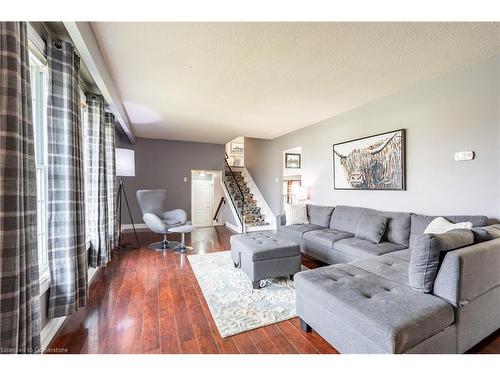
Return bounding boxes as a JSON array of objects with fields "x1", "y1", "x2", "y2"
[{"x1": 409, "y1": 229, "x2": 474, "y2": 293}]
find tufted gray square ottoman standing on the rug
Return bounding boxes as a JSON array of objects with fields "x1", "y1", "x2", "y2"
[{"x1": 230, "y1": 231, "x2": 300, "y2": 289}]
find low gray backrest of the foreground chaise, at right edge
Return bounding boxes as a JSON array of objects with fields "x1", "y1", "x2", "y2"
[{"x1": 433, "y1": 238, "x2": 500, "y2": 307}]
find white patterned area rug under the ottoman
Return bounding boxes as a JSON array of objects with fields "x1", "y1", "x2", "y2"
[{"x1": 188, "y1": 251, "x2": 297, "y2": 337}]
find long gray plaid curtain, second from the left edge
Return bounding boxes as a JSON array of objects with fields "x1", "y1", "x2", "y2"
[{"x1": 47, "y1": 37, "x2": 88, "y2": 318}]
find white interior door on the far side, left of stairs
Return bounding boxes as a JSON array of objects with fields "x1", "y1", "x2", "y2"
[{"x1": 191, "y1": 181, "x2": 214, "y2": 227}]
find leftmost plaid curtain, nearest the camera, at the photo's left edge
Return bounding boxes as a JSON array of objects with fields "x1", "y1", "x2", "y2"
[{"x1": 0, "y1": 22, "x2": 41, "y2": 353}]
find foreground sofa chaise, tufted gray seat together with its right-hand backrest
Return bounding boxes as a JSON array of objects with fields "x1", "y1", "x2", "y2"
[{"x1": 295, "y1": 234, "x2": 500, "y2": 353}]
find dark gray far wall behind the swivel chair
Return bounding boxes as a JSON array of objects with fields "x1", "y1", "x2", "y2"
[{"x1": 116, "y1": 133, "x2": 233, "y2": 224}]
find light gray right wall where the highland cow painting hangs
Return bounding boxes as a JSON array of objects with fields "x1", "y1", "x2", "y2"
[{"x1": 245, "y1": 55, "x2": 500, "y2": 219}]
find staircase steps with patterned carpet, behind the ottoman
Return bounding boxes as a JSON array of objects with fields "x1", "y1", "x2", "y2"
[{"x1": 224, "y1": 159, "x2": 269, "y2": 232}]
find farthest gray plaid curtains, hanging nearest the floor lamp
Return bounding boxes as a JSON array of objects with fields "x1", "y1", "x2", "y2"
[{"x1": 85, "y1": 94, "x2": 116, "y2": 267}]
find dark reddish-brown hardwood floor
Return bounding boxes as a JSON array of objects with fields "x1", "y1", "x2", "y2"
[{"x1": 46, "y1": 227, "x2": 500, "y2": 354}]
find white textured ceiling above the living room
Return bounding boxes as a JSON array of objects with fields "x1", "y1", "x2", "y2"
[{"x1": 92, "y1": 22, "x2": 500, "y2": 143}]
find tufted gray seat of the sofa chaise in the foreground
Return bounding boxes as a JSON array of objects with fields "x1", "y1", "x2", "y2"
[{"x1": 295, "y1": 264, "x2": 454, "y2": 353}]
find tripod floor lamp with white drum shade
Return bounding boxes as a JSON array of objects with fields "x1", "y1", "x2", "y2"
[{"x1": 115, "y1": 148, "x2": 140, "y2": 250}]
